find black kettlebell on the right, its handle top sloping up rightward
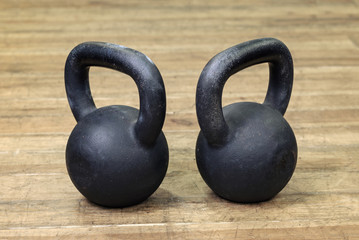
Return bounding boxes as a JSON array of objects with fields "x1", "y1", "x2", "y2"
[{"x1": 196, "y1": 38, "x2": 297, "y2": 203}]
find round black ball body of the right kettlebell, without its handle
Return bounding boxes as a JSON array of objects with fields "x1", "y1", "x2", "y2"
[{"x1": 196, "y1": 102, "x2": 297, "y2": 203}]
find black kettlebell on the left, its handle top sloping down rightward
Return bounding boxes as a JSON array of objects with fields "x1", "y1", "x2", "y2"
[{"x1": 65, "y1": 42, "x2": 168, "y2": 207}]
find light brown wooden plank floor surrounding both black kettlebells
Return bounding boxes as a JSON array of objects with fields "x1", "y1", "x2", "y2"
[{"x1": 0, "y1": 0, "x2": 359, "y2": 240}]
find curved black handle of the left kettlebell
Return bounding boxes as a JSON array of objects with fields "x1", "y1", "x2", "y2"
[{"x1": 65, "y1": 42, "x2": 166, "y2": 145}]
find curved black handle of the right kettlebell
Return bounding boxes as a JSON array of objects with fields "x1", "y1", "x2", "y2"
[{"x1": 196, "y1": 38, "x2": 293, "y2": 146}]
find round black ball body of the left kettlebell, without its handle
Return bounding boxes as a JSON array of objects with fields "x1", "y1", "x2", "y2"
[{"x1": 66, "y1": 106, "x2": 168, "y2": 207}]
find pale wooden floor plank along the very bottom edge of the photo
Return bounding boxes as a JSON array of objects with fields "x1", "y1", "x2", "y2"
[{"x1": 0, "y1": 223, "x2": 358, "y2": 240}]
